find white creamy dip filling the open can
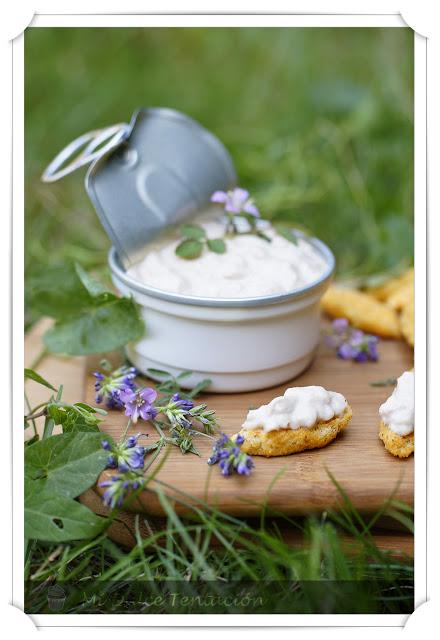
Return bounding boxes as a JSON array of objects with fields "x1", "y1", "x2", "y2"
[{"x1": 127, "y1": 221, "x2": 328, "y2": 298}]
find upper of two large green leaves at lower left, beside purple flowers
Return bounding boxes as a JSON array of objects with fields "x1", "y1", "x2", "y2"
[{"x1": 25, "y1": 433, "x2": 107, "y2": 498}]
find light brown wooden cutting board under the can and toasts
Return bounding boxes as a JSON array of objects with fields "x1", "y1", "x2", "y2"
[{"x1": 84, "y1": 341, "x2": 414, "y2": 516}]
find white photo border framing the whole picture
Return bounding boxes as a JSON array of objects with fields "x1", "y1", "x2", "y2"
[{"x1": 13, "y1": 14, "x2": 427, "y2": 627}]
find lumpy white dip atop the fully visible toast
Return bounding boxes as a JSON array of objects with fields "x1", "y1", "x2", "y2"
[{"x1": 243, "y1": 387, "x2": 347, "y2": 431}]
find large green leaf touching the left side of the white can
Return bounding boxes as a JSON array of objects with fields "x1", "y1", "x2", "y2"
[{"x1": 43, "y1": 294, "x2": 145, "y2": 355}]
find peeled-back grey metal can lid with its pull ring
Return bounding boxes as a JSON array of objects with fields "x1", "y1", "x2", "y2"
[{"x1": 42, "y1": 108, "x2": 236, "y2": 267}]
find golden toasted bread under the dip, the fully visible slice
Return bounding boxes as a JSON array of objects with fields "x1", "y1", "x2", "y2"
[{"x1": 233, "y1": 405, "x2": 353, "y2": 458}]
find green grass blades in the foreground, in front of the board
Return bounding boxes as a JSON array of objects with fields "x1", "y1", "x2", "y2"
[{"x1": 25, "y1": 480, "x2": 414, "y2": 613}]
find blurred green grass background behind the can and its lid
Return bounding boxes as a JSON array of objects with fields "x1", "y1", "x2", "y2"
[{"x1": 25, "y1": 28, "x2": 413, "y2": 320}]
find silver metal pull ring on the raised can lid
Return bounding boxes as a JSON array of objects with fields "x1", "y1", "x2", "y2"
[{"x1": 41, "y1": 123, "x2": 129, "y2": 182}]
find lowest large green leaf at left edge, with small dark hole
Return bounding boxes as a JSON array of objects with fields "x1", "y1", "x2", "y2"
[{"x1": 24, "y1": 479, "x2": 105, "y2": 542}]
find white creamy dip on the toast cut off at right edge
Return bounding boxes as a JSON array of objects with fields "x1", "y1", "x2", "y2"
[{"x1": 379, "y1": 371, "x2": 414, "y2": 436}]
